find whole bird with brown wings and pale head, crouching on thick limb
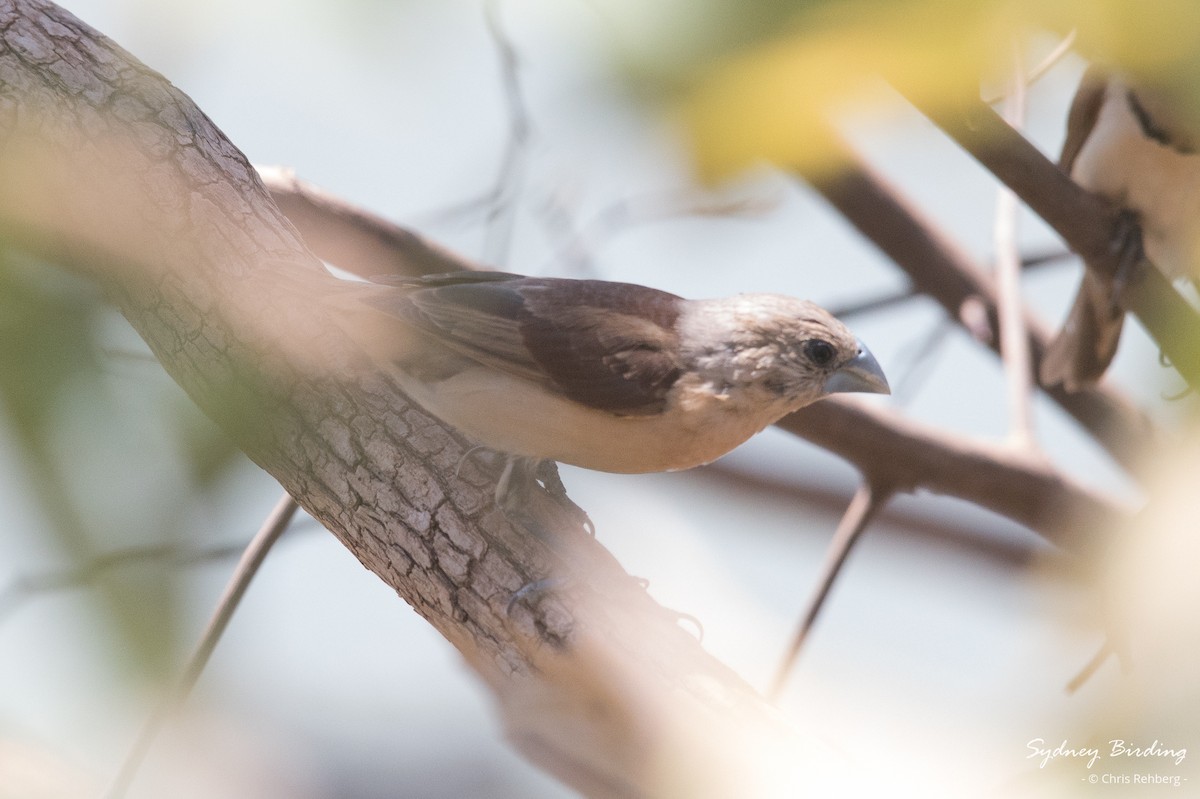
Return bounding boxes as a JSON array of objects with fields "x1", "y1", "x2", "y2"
[{"x1": 350, "y1": 271, "x2": 890, "y2": 513}]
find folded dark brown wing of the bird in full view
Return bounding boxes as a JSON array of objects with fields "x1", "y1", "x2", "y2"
[{"x1": 371, "y1": 272, "x2": 682, "y2": 415}]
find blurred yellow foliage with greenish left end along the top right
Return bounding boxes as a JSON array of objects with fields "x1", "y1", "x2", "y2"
[{"x1": 604, "y1": 0, "x2": 1200, "y2": 179}]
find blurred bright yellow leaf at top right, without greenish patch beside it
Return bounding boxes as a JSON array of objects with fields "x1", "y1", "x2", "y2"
[{"x1": 676, "y1": 0, "x2": 1200, "y2": 180}]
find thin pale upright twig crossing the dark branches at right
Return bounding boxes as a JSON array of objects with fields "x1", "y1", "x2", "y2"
[{"x1": 995, "y1": 44, "x2": 1034, "y2": 449}]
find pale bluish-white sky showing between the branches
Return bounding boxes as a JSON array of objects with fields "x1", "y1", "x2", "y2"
[{"x1": 0, "y1": 0, "x2": 1177, "y2": 799}]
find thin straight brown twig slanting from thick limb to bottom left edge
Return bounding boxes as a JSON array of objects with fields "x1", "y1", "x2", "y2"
[{"x1": 106, "y1": 493, "x2": 299, "y2": 799}]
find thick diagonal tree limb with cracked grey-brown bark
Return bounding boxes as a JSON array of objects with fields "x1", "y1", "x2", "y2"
[{"x1": 0, "y1": 0, "x2": 808, "y2": 797}]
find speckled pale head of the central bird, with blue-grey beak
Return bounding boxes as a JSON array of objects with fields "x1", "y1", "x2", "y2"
[{"x1": 680, "y1": 294, "x2": 890, "y2": 415}]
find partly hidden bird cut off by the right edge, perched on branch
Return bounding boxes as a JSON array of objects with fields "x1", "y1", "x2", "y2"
[{"x1": 1039, "y1": 65, "x2": 1200, "y2": 391}]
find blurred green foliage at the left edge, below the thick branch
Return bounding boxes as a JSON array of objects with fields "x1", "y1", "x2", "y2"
[{"x1": 0, "y1": 244, "x2": 238, "y2": 672}]
